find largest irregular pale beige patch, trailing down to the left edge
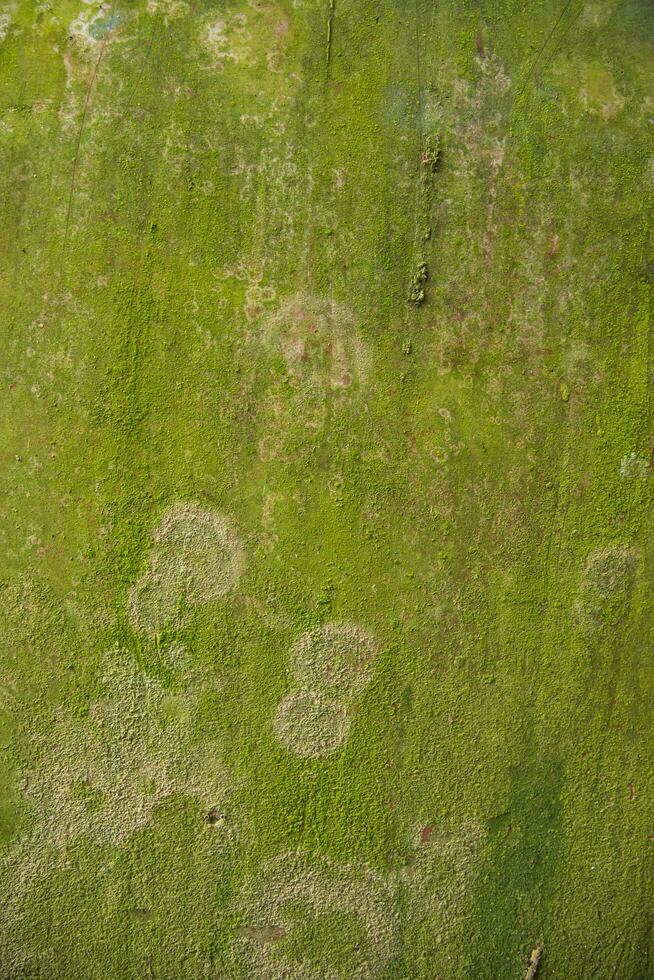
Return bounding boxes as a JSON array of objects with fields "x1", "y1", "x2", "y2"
[{"x1": 0, "y1": 650, "x2": 228, "y2": 948}]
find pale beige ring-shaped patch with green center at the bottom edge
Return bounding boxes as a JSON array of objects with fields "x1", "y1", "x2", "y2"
[{"x1": 234, "y1": 852, "x2": 398, "y2": 980}]
